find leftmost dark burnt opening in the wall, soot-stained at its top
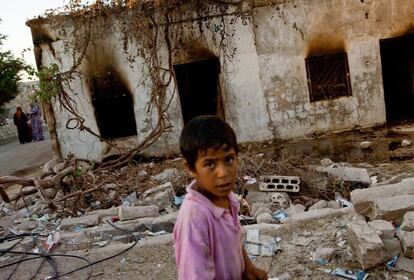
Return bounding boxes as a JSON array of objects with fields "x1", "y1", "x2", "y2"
[{"x1": 92, "y1": 70, "x2": 137, "y2": 139}]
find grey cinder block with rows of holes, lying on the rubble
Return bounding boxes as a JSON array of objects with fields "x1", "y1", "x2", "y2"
[{"x1": 259, "y1": 175, "x2": 300, "y2": 192}]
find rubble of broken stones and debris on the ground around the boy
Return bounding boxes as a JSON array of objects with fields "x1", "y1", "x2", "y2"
[{"x1": 0, "y1": 147, "x2": 414, "y2": 279}]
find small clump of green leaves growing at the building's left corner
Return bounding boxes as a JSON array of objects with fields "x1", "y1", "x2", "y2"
[{"x1": 30, "y1": 64, "x2": 61, "y2": 103}]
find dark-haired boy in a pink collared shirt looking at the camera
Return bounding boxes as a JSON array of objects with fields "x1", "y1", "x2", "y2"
[{"x1": 174, "y1": 116, "x2": 267, "y2": 280}]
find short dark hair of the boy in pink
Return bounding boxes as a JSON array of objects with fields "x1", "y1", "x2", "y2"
[{"x1": 180, "y1": 115, "x2": 239, "y2": 170}]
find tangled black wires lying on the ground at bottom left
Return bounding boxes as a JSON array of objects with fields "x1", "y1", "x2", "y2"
[{"x1": 0, "y1": 220, "x2": 139, "y2": 280}]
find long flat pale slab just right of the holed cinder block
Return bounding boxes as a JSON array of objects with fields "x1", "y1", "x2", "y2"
[{"x1": 311, "y1": 164, "x2": 371, "y2": 186}]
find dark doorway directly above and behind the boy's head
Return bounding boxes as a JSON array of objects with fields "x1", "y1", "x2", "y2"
[{"x1": 174, "y1": 58, "x2": 224, "y2": 123}]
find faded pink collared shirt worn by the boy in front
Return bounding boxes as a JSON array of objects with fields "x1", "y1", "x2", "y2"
[{"x1": 173, "y1": 181, "x2": 244, "y2": 280}]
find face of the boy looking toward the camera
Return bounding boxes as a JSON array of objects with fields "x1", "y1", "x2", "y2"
[{"x1": 190, "y1": 145, "x2": 238, "y2": 202}]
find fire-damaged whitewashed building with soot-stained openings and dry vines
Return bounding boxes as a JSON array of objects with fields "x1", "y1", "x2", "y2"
[{"x1": 27, "y1": 0, "x2": 414, "y2": 161}]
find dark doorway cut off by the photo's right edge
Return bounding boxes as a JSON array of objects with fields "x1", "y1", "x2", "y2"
[{"x1": 380, "y1": 35, "x2": 414, "y2": 122}]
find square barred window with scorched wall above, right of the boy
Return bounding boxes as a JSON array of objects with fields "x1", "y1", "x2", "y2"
[{"x1": 305, "y1": 53, "x2": 352, "y2": 102}]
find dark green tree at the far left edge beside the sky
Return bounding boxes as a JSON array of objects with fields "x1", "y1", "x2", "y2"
[{"x1": 0, "y1": 19, "x2": 27, "y2": 112}]
